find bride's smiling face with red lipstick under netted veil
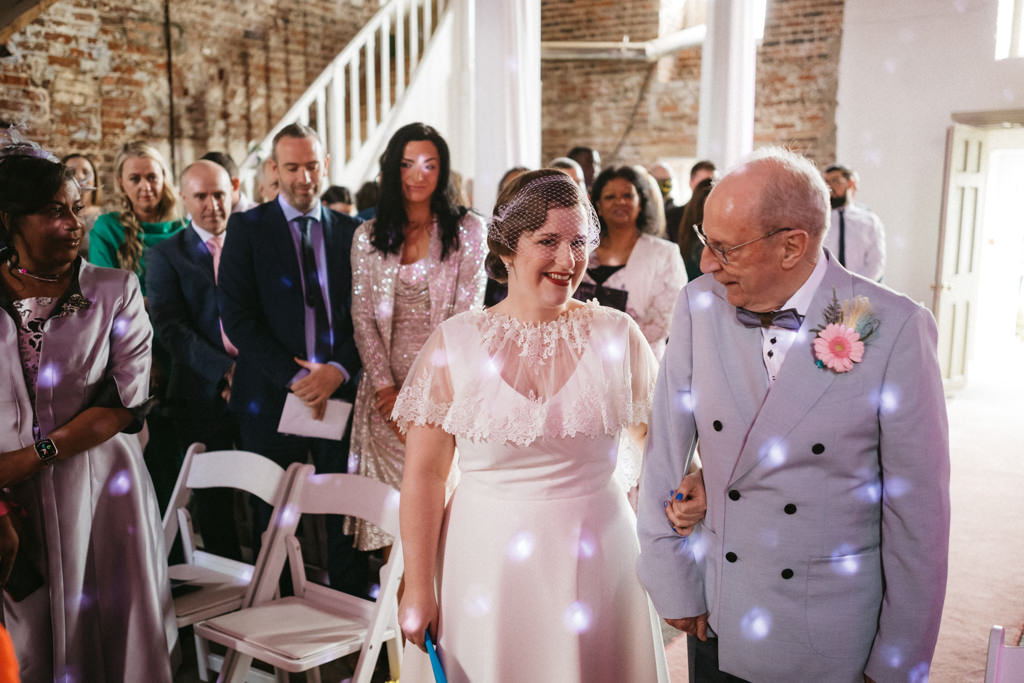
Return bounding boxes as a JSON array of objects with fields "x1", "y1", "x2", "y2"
[{"x1": 508, "y1": 206, "x2": 587, "y2": 308}]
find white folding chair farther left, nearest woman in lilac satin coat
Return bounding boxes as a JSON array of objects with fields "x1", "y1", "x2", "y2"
[{"x1": 164, "y1": 443, "x2": 298, "y2": 681}]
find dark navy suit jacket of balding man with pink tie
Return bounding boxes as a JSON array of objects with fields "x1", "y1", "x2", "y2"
[{"x1": 145, "y1": 226, "x2": 234, "y2": 416}]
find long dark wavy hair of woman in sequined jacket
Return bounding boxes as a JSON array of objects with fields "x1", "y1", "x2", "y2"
[{"x1": 370, "y1": 123, "x2": 468, "y2": 260}]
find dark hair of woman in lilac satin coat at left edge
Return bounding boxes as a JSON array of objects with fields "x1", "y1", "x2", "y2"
[{"x1": 0, "y1": 155, "x2": 74, "y2": 272}]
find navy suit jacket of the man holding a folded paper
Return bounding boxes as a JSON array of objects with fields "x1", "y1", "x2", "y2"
[{"x1": 218, "y1": 201, "x2": 360, "y2": 420}]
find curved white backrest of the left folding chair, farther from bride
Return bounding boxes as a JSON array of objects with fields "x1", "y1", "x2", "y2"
[{"x1": 163, "y1": 443, "x2": 288, "y2": 556}]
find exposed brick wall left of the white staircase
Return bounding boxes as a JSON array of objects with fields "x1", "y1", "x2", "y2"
[{"x1": 0, "y1": 0, "x2": 376, "y2": 208}]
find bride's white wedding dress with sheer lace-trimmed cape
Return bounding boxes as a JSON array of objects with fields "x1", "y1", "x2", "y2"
[{"x1": 394, "y1": 302, "x2": 669, "y2": 683}]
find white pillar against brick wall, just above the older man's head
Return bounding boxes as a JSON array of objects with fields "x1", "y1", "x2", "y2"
[{"x1": 697, "y1": 0, "x2": 758, "y2": 169}]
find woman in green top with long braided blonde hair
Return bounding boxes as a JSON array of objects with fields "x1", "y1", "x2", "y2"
[{"x1": 89, "y1": 141, "x2": 184, "y2": 294}]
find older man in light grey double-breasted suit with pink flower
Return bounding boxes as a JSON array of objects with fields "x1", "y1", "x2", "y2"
[{"x1": 639, "y1": 148, "x2": 949, "y2": 683}]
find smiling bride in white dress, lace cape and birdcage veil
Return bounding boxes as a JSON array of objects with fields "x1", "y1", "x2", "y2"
[{"x1": 393, "y1": 170, "x2": 668, "y2": 683}]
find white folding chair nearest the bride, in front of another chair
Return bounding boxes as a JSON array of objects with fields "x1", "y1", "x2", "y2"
[{"x1": 196, "y1": 465, "x2": 403, "y2": 683}]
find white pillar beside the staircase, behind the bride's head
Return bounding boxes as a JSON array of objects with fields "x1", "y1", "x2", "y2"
[{"x1": 468, "y1": 0, "x2": 541, "y2": 214}]
